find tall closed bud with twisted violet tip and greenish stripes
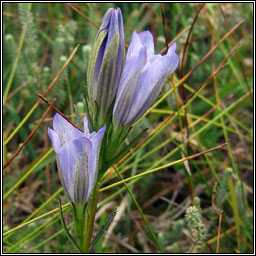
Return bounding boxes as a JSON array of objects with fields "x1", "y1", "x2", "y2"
[{"x1": 87, "y1": 8, "x2": 125, "y2": 128}]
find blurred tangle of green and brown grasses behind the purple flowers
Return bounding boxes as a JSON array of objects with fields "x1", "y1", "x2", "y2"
[{"x1": 3, "y1": 3, "x2": 254, "y2": 253}]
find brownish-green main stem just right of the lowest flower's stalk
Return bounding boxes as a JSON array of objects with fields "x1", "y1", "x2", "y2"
[{"x1": 83, "y1": 181, "x2": 100, "y2": 253}]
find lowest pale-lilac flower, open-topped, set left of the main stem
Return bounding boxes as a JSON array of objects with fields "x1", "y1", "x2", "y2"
[{"x1": 48, "y1": 114, "x2": 106, "y2": 204}]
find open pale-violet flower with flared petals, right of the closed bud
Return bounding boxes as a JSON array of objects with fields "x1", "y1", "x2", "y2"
[{"x1": 113, "y1": 31, "x2": 179, "y2": 127}]
